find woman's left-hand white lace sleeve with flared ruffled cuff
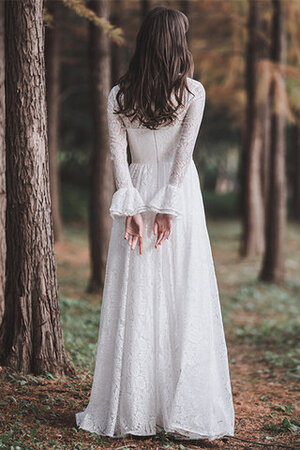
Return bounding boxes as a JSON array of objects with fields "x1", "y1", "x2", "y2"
[{"x1": 107, "y1": 86, "x2": 147, "y2": 219}]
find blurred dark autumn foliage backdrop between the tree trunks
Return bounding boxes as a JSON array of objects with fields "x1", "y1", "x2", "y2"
[{"x1": 54, "y1": 0, "x2": 300, "y2": 223}]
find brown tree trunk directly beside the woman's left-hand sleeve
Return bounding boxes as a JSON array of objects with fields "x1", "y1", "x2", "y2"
[{"x1": 88, "y1": 0, "x2": 114, "y2": 293}]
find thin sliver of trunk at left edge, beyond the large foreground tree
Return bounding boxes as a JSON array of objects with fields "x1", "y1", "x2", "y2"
[{"x1": 0, "y1": 2, "x2": 6, "y2": 323}]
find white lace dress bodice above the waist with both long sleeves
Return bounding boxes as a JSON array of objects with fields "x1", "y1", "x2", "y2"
[{"x1": 107, "y1": 77, "x2": 205, "y2": 217}]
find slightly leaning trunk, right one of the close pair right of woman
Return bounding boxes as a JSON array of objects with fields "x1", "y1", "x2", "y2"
[{"x1": 260, "y1": 0, "x2": 287, "y2": 284}]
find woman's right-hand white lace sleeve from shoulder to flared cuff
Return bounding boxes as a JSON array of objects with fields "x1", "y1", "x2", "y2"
[{"x1": 148, "y1": 83, "x2": 205, "y2": 217}]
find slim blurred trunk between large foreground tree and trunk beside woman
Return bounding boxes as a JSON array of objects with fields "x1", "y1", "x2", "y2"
[{"x1": 45, "y1": 0, "x2": 63, "y2": 241}]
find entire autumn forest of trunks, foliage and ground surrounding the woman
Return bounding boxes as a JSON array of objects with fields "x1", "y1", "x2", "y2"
[{"x1": 0, "y1": 0, "x2": 300, "y2": 450}]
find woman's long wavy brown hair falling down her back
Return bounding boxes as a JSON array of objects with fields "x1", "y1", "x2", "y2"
[{"x1": 116, "y1": 6, "x2": 194, "y2": 129}]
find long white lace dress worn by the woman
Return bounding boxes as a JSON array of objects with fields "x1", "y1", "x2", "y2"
[{"x1": 76, "y1": 78, "x2": 234, "y2": 440}]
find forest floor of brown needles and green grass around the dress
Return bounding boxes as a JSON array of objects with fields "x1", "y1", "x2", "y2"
[{"x1": 0, "y1": 221, "x2": 300, "y2": 450}]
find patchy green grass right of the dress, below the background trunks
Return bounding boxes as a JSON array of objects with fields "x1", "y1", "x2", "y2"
[{"x1": 209, "y1": 221, "x2": 300, "y2": 379}]
